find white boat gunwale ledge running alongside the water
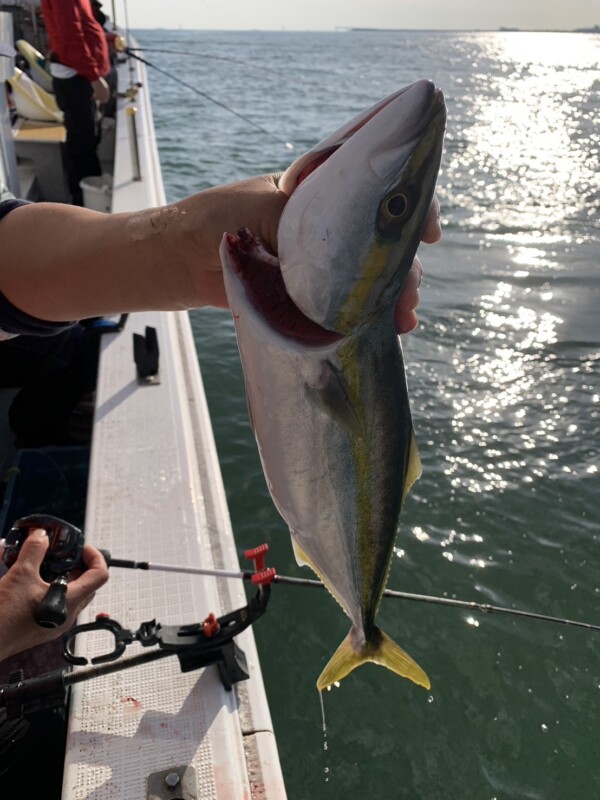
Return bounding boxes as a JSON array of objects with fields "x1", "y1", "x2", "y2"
[{"x1": 63, "y1": 47, "x2": 285, "y2": 800}]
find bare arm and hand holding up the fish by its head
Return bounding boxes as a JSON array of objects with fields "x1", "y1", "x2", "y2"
[{"x1": 0, "y1": 175, "x2": 440, "y2": 332}]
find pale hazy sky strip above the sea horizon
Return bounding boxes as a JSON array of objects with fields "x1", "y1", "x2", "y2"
[{"x1": 120, "y1": 0, "x2": 600, "y2": 30}]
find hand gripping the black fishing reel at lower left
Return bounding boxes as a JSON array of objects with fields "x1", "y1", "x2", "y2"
[{"x1": 0, "y1": 530, "x2": 108, "y2": 661}]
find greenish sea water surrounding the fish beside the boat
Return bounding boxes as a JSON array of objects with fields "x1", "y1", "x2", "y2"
[{"x1": 136, "y1": 30, "x2": 600, "y2": 800}]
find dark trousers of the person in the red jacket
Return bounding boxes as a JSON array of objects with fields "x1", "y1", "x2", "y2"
[{"x1": 53, "y1": 75, "x2": 102, "y2": 206}]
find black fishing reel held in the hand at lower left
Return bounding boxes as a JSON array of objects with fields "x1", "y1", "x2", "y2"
[{"x1": 2, "y1": 514, "x2": 85, "y2": 628}]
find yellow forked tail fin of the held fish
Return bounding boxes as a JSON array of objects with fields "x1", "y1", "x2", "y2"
[{"x1": 317, "y1": 627, "x2": 431, "y2": 692}]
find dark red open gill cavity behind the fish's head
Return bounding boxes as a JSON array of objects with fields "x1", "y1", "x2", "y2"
[{"x1": 226, "y1": 228, "x2": 344, "y2": 347}]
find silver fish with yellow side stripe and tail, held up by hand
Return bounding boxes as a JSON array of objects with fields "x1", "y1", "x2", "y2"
[{"x1": 220, "y1": 80, "x2": 446, "y2": 691}]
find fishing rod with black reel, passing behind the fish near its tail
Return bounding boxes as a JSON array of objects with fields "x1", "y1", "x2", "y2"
[{"x1": 0, "y1": 514, "x2": 600, "y2": 631}]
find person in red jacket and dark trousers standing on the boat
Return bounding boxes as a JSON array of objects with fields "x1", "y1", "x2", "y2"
[{"x1": 41, "y1": 0, "x2": 110, "y2": 206}]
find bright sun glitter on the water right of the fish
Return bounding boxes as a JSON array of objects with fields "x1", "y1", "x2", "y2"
[{"x1": 442, "y1": 34, "x2": 600, "y2": 494}]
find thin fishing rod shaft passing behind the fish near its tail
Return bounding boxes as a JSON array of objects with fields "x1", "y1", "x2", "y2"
[{"x1": 105, "y1": 554, "x2": 600, "y2": 631}]
